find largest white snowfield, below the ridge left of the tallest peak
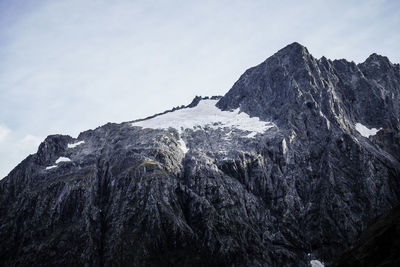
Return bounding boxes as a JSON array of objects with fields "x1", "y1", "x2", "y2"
[{"x1": 132, "y1": 99, "x2": 276, "y2": 138}]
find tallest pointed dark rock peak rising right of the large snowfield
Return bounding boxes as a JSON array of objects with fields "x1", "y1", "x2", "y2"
[{"x1": 218, "y1": 43, "x2": 324, "y2": 127}]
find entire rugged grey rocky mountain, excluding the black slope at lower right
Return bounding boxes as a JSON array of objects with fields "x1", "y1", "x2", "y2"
[{"x1": 0, "y1": 43, "x2": 400, "y2": 266}]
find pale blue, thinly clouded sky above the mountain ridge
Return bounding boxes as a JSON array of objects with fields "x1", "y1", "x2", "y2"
[{"x1": 0, "y1": 0, "x2": 400, "y2": 179}]
